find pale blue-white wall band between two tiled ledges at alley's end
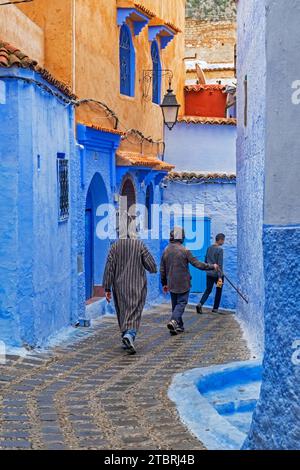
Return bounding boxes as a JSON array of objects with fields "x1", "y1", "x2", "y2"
[{"x1": 165, "y1": 122, "x2": 236, "y2": 173}]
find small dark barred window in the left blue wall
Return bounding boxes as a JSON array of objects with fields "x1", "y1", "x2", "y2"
[{"x1": 57, "y1": 153, "x2": 69, "y2": 221}]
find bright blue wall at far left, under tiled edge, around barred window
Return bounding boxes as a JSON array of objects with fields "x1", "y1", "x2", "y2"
[{"x1": 0, "y1": 69, "x2": 77, "y2": 346}]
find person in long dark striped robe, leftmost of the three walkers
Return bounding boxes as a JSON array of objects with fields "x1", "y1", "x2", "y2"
[{"x1": 103, "y1": 238, "x2": 157, "y2": 354}]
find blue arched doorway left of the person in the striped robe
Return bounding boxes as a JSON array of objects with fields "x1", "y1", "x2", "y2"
[{"x1": 84, "y1": 173, "x2": 110, "y2": 300}]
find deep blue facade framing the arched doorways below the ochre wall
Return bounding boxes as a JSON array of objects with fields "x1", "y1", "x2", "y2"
[{"x1": 77, "y1": 125, "x2": 163, "y2": 316}]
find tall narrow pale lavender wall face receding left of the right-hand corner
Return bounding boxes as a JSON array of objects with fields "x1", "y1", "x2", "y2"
[{"x1": 237, "y1": 0, "x2": 266, "y2": 355}]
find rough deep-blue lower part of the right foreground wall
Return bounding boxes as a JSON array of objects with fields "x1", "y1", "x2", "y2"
[{"x1": 244, "y1": 225, "x2": 300, "y2": 450}]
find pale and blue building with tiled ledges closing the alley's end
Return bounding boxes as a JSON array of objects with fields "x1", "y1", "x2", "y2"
[{"x1": 164, "y1": 116, "x2": 237, "y2": 310}]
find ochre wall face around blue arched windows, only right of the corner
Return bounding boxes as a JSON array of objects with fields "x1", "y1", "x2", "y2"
[{"x1": 75, "y1": 0, "x2": 185, "y2": 139}]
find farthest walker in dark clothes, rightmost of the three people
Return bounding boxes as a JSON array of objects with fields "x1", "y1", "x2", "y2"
[{"x1": 196, "y1": 233, "x2": 225, "y2": 314}]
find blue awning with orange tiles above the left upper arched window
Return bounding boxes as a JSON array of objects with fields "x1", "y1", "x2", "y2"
[{"x1": 117, "y1": 0, "x2": 155, "y2": 36}]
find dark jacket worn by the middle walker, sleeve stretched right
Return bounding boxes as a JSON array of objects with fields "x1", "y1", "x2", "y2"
[{"x1": 160, "y1": 242, "x2": 214, "y2": 294}]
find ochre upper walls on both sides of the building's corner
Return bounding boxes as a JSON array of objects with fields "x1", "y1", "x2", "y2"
[{"x1": 19, "y1": 0, "x2": 185, "y2": 140}]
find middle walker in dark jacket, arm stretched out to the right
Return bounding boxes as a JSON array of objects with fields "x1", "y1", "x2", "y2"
[{"x1": 160, "y1": 227, "x2": 218, "y2": 335}]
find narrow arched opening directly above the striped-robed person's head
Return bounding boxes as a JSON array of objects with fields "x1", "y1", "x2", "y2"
[{"x1": 119, "y1": 177, "x2": 136, "y2": 238}]
